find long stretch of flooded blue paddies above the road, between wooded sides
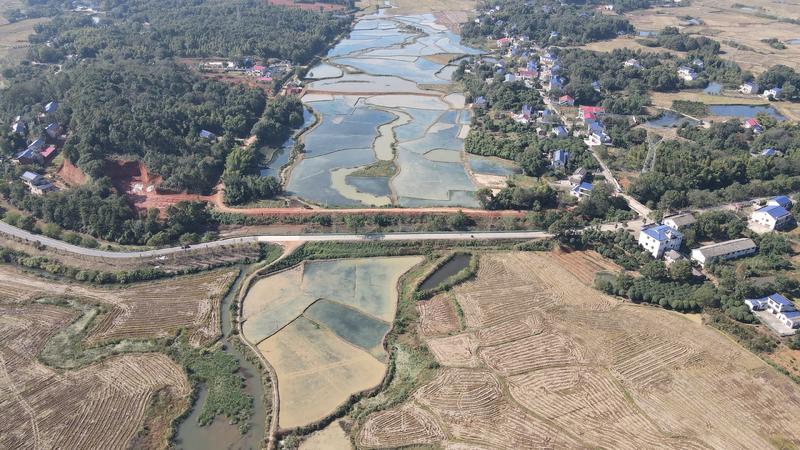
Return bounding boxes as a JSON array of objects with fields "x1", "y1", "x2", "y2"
[{"x1": 287, "y1": 10, "x2": 496, "y2": 207}]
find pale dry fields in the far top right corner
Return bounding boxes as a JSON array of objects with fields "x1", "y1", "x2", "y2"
[{"x1": 626, "y1": 0, "x2": 800, "y2": 73}]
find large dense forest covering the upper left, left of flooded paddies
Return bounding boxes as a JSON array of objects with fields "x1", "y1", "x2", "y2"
[{"x1": 0, "y1": 0, "x2": 350, "y2": 245}]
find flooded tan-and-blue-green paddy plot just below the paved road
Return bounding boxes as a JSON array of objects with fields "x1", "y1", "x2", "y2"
[{"x1": 242, "y1": 256, "x2": 422, "y2": 429}]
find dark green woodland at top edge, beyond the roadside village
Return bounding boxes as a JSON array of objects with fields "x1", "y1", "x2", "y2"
[{"x1": 461, "y1": 0, "x2": 633, "y2": 45}]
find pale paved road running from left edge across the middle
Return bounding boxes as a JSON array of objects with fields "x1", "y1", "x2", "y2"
[{"x1": 0, "y1": 222, "x2": 553, "y2": 259}]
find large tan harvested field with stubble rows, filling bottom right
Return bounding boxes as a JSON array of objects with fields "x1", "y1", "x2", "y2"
[{"x1": 355, "y1": 252, "x2": 800, "y2": 449}]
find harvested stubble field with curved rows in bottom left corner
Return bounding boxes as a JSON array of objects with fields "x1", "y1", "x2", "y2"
[{"x1": 0, "y1": 304, "x2": 191, "y2": 449}]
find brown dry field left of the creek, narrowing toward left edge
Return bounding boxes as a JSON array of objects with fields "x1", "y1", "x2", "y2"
[{"x1": 0, "y1": 267, "x2": 237, "y2": 346}]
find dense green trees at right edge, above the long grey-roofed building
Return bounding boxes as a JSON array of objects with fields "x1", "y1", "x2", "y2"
[{"x1": 629, "y1": 116, "x2": 800, "y2": 209}]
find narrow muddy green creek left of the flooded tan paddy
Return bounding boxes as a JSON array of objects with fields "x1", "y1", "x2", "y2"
[{"x1": 175, "y1": 267, "x2": 267, "y2": 450}]
